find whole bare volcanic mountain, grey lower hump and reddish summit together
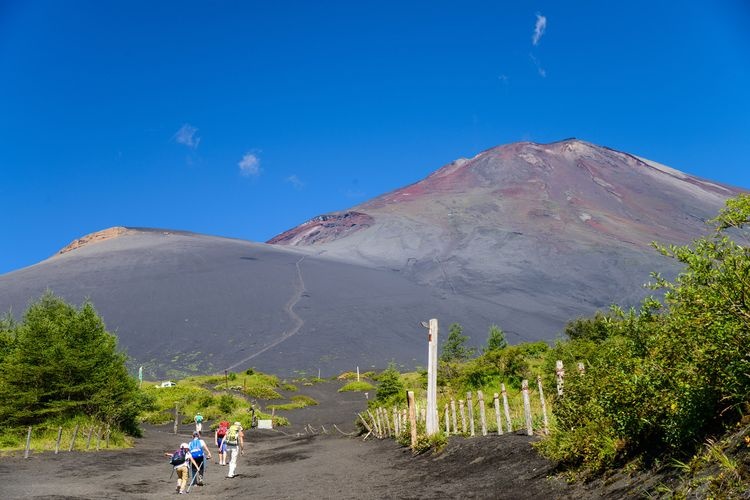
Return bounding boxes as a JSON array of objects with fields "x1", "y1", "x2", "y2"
[{"x1": 0, "y1": 140, "x2": 740, "y2": 376}]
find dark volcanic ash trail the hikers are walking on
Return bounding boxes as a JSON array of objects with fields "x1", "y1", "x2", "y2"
[{"x1": 0, "y1": 382, "x2": 640, "y2": 499}]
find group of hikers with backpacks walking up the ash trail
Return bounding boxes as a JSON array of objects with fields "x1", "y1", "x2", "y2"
[{"x1": 165, "y1": 413, "x2": 245, "y2": 494}]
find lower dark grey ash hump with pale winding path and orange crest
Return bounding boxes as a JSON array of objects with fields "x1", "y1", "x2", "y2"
[{"x1": 0, "y1": 228, "x2": 512, "y2": 378}]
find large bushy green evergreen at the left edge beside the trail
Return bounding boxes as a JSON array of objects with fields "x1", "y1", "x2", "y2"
[{"x1": 0, "y1": 292, "x2": 145, "y2": 433}]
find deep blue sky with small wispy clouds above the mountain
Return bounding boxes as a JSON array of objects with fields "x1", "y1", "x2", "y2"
[{"x1": 0, "y1": 0, "x2": 750, "y2": 274}]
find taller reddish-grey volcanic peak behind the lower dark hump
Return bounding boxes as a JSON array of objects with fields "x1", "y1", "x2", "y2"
[{"x1": 268, "y1": 139, "x2": 740, "y2": 332}]
